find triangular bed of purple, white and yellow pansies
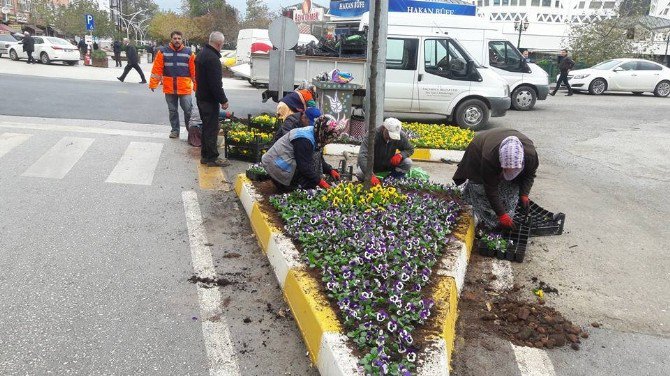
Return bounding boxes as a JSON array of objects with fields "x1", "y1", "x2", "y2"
[{"x1": 270, "y1": 180, "x2": 470, "y2": 375}]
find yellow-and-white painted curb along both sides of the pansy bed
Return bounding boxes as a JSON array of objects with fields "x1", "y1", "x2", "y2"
[{"x1": 235, "y1": 174, "x2": 475, "y2": 376}]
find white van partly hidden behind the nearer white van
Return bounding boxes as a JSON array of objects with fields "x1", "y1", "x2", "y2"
[{"x1": 370, "y1": 12, "x2": 549, "y2": 111}]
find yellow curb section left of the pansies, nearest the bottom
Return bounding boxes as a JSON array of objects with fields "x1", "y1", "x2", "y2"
[{"x1": 284, "y1": 269, "x2": 342, "y2": 364}]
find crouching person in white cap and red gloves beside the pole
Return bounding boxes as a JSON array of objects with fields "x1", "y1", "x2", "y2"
[{"x1": 356, "y1": 118, "x2": 414, "y2": 185}]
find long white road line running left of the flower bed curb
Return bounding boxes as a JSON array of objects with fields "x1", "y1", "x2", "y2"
[{"x1": 182, "y1": 191, "x2": 240, "y2": 376}]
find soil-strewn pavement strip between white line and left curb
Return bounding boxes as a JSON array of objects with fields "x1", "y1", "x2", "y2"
[{"x1": 196, "y1": 191, "x2": 318, "y2": 376}]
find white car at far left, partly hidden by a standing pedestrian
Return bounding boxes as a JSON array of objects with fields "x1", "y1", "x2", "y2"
[{"x1": 9, "y1": 36, "x2": 79, "y2": 65}]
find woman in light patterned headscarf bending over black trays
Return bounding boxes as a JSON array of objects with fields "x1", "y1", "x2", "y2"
[{"x1": 453, "y1": 128, "x2": 539, "y2": 228}]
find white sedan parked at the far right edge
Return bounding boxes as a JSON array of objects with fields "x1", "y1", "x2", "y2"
[{"x1": 568, "y1": 59, "x2": 670, "y2": 97}]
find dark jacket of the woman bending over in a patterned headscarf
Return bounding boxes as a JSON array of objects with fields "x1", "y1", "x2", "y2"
[{"x1": 453, "y1": 128, "x2": 539, "y2": 215}]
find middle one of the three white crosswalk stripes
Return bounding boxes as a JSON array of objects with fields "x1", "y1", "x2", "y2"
[{"x1": 22, "y1": 137, "x2": 94, "y2": 179}]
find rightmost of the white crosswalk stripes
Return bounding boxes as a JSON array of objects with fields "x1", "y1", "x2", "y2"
[{"x1": 105, "y1": 142, "x2": 163, "y2": 185}]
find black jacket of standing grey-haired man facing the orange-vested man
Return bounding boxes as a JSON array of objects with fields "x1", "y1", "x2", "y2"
[{"x1": 195, "y1": 44, "x2": 228, "y2": 104}]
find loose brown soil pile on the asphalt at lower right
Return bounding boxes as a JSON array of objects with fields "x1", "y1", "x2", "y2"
[{"x1": 481, "y1": 298, "x2": 589, "y2": 350}]
